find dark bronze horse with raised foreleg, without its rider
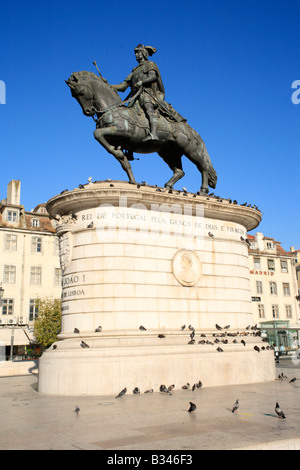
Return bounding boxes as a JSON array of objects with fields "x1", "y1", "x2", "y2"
[{"x1": 66, "y1": 71, "x2": 217, "y2": 194}]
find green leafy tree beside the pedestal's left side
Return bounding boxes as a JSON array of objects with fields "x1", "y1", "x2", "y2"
[{"x1": 34, "y1": 297, "x2": 61, "y2": 349}]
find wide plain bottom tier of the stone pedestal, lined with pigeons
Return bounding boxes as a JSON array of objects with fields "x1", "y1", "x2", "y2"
[{"x1": 39, "y1": 331, "x2": 275, "y2": 396}]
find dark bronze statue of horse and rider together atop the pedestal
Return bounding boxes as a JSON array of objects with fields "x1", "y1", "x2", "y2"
[{"x1": 66, "y1": 44, "x2": 217, "y2": 194}]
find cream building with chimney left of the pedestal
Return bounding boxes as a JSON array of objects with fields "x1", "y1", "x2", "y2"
[{"x1": 0, "y1": 180, "x2": 61, "y2": 356}]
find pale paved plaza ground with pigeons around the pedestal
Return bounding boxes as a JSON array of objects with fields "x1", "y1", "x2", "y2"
[{"x1": 0, "y1": 359, "x2": 300, "y2": 452}]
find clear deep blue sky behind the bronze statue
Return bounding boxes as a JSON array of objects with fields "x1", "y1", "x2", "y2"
[{"x1": 0, "y1": 0, "x2": 300, "y2": 250}]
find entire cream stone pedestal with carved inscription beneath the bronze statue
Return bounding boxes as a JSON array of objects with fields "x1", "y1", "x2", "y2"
[{"x1": 39, "y1": 181, "x2": 275, "y2": 395}]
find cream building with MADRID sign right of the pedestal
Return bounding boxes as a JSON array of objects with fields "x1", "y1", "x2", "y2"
[{"x1": 248, "y1": 232, "x2": 300, "y2": 348}]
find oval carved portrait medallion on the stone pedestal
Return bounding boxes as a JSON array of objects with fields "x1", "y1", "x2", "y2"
[{"x1": 173, "y1": 250, "x2": 202, "y2": 286}]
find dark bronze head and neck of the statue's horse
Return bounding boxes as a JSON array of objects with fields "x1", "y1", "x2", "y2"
[{"x1": 66, "y1": 71, "x2": 122, "y2": 116}]
